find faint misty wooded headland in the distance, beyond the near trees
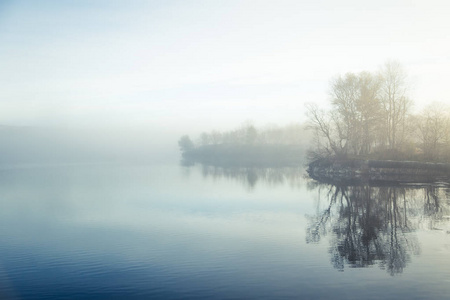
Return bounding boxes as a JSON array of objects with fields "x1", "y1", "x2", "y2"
[{"x1": 178, "y1": 122, "x2": 311, "y2": 166}]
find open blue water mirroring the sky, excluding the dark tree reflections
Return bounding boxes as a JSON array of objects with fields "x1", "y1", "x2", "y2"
[{"x1": 0, "y1": 165, "x2": 450, "y2": 299}]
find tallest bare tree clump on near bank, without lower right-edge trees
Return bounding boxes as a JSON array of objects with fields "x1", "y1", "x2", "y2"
[{"x1": 307, "y1": 62, "x2": 412, "y2": 161}]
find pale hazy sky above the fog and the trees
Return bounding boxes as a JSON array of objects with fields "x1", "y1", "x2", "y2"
[{"x1": 0, "y1": 0, "x2": 450, "y2": 131}]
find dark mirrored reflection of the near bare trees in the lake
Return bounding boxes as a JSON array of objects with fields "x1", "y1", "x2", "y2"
[{"x1": 306, "y1": 185, "x2": 449, "y2": 275}]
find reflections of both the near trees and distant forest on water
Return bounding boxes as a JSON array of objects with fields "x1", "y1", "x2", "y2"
[{"x1": 180, "y1": 164, "x2": 450, "y2": 275}]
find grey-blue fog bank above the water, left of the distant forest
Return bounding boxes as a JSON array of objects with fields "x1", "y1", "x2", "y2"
[{"x1": 0, "y1": 126, "x2": 179, "y2": 168}]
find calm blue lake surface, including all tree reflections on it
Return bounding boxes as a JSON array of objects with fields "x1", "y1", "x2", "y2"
[{"x1": 0, "y1": 164, "x2": 450, "y2": 299}]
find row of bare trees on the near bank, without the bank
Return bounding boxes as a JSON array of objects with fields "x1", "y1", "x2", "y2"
[{"x1": 307, "y1": 61, "x2": 450, "y2": 161}]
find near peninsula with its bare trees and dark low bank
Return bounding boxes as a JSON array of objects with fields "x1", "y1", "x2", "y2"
[{"x1": 307, "y1": 61, "x2": 450, "y2": 182}]
